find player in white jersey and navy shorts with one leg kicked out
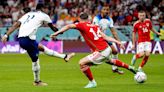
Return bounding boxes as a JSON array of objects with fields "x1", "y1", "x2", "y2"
[{"x1": 2, "y1": 4, "x2": 73, "y2": 86}]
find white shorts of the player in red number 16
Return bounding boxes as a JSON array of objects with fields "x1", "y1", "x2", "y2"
[{"x1": 137, "y1": 42, "x2": 152, "y2": 53}]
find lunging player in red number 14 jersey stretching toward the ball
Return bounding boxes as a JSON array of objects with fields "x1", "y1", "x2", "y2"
[{"x1": 51, "y1": 13, "x2": 136, "y2": 88}]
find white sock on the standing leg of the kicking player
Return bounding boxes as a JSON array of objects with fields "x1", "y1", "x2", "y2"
[{"x1": 32, "y1": 59, "x2": 40, "y2": 81}]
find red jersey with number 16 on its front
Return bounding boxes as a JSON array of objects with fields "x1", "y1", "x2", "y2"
[{"x1": 133, "y1": 19, "x2": 152, "y2": 43}]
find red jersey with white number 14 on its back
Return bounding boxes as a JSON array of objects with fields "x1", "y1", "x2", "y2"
[{"x1": 75, "y1": 22, "x2": 108, "y2": 51}]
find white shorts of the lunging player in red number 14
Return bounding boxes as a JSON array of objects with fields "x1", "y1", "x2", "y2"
[{"x1": 87, "y1": 47, "x2": 112, "y2": 64}]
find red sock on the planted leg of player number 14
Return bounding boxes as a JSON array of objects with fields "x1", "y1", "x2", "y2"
[{"x1": 81, "y1": 65, "x2": 93, "y2": 81}]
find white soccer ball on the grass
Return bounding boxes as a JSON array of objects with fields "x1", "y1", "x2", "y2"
[{"x1": 134, "y1": 72, "x2": 147, "y2": 83}]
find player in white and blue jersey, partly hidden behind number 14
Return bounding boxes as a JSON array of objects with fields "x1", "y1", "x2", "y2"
[{"x1": 93, "y1": 5, "x2": 124, "y2": 74}]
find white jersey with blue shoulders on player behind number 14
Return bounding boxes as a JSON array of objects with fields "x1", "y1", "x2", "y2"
[{"x1": 92, "y1": 14, "x2": 114, "y2": 30}]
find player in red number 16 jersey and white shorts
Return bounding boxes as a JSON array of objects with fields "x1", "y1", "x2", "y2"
[{"x1": 131, "y1": 10, "x2": 161, "y2": 71}]
